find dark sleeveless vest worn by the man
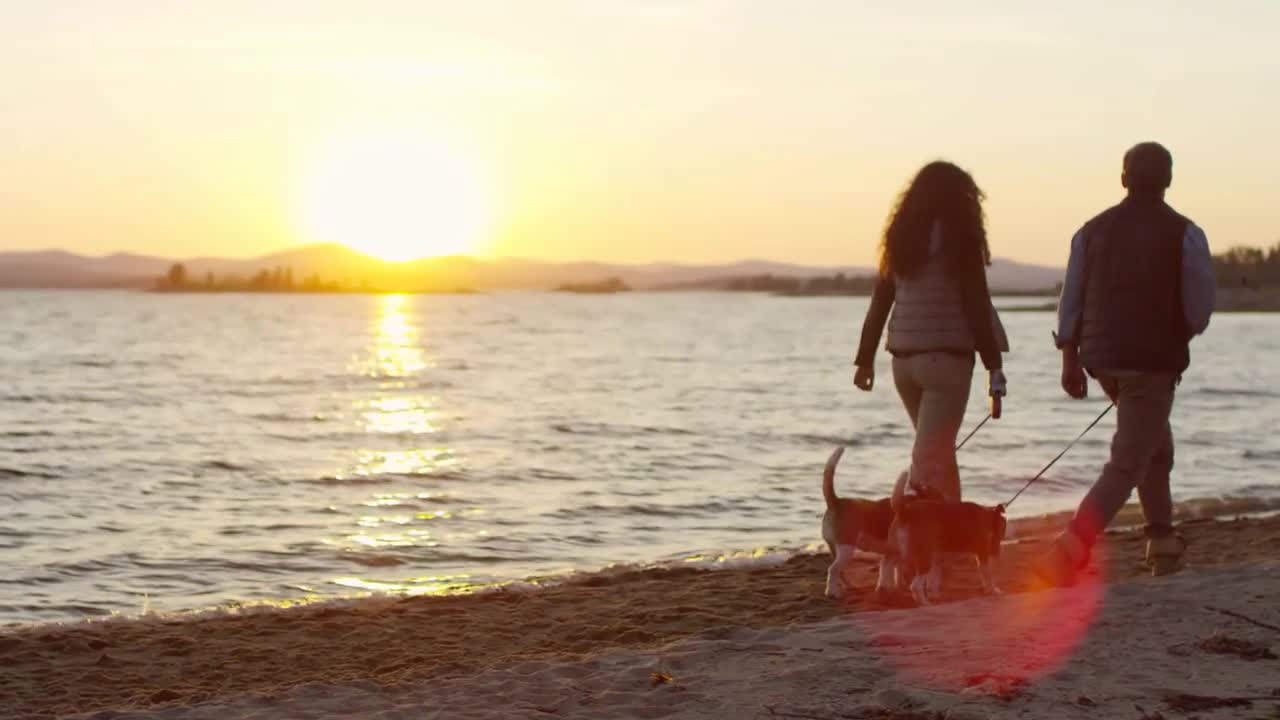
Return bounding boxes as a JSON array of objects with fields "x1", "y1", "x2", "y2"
[{"x1": 1079, "y1": 196, "x2": 1190, "y2": 373}]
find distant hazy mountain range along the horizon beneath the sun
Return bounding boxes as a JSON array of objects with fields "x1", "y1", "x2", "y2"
[{"x1": 0, "y1": 245, "x2": 1062, "y2": 292}]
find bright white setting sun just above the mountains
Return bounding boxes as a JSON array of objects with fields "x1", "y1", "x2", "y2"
[{"x1": 298, "y1": 129, "x2": 489, "y2": 261}]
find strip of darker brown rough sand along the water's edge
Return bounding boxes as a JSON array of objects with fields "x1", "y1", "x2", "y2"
[{"x1": 0, "y1": 504, "x2": 1280, "y2": 717}]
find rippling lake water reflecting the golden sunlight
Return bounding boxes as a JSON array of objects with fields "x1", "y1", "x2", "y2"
[{"x1": 0, "y1": 292, "x2": 1280, "y2": 623}]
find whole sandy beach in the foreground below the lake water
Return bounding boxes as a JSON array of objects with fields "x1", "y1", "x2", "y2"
[{"x1": 0, "y1": 507, "x2": 1280, "y2": 720}]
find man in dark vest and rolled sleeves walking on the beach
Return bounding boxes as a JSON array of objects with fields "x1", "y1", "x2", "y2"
[{"x1": 1037, "y1": 142, "x2": 1216, "y2": 584}]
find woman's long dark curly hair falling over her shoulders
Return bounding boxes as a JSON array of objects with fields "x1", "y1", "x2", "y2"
[{"x1": 879, "y1": 160, "x2": 991, "y2": 277}]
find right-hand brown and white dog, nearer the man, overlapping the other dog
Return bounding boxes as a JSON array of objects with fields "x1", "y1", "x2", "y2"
[{"x1": 891, "y1": 500, "x2": 1006, "y2": 605}]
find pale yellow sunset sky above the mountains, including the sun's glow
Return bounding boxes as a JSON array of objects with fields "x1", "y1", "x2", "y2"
[{"x1": 0, "y1": 0, "x2": 1280, "y2": 264}]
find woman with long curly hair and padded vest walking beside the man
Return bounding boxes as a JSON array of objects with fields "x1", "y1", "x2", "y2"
[{"x1": 854, "y1": 161, "x2": 1009, "y2": 501}]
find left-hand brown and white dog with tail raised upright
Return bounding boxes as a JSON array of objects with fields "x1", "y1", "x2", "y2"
[{"x1": 822, "y1": 447, "x2": 942, "y2": 600}]
